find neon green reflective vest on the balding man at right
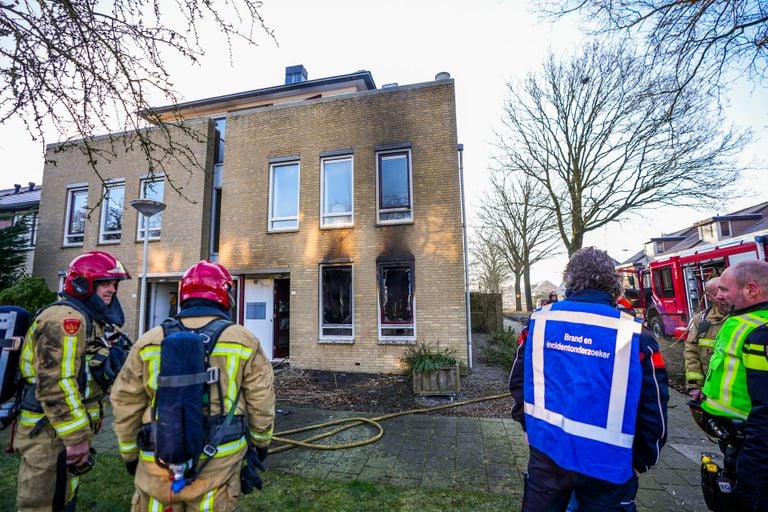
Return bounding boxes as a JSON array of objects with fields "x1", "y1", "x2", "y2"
[{"x1": 701, "y1": 306, "x2": 768, "y2": 420}]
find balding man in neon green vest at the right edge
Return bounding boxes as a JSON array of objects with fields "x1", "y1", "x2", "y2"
[{"x1": 701, "y1": 260, "x2": 768, "y2": 511}]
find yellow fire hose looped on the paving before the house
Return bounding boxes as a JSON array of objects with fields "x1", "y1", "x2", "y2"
[{"x1": 269, "y1": 393, "x2": 509, "y2": 453}]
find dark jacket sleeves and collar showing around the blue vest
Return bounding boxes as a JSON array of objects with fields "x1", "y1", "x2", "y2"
[{"x1": 509, "y1": 289, "x2": 669, "y2": 473}]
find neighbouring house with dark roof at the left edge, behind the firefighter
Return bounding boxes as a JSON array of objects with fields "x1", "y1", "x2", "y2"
[{"x1": 0, "y1": 181, "x2": 42, "y2": 274}]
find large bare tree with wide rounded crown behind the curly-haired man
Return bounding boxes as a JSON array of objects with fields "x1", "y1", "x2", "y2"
[{"x1": 499, "y1": 43, "x2": 748, "y2": 255}]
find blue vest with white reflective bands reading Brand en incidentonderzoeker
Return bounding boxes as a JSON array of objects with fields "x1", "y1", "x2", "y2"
[{"x1": 524, "y1": 300, "x2": 642, "y2": 483}]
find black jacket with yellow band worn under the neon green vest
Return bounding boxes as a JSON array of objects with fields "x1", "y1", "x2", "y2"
[{"x1": 736, "y1": 303, "x2": 768, "y2": 502}]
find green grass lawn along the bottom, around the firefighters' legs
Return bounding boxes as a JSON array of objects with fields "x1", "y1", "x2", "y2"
[{"x1": 0, "y1": 452, "x2": 520, "y2": 512}]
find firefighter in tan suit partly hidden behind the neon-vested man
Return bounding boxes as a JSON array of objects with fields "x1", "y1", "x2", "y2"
[{"x1": 684, "y1": 277, "x2": 728, "y2": 401}]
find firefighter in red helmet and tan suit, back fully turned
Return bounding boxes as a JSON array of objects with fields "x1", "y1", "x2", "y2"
[{"x1": 110, "y1": 261, "x2": 275, "y2": 512}]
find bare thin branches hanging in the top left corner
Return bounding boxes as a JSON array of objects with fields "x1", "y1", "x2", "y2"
[{"x1": 0, "y1": 0, "x2": 273, "y2": 198}]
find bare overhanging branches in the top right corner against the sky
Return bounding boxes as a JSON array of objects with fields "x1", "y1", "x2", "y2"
[{"x1": 537, "y1": 0, "x2": 768, "y2": 105}]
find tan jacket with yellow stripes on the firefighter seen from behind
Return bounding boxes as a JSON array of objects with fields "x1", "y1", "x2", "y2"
[{"x1": 110, "y1": 315, "x2": 275, "y2": 502}]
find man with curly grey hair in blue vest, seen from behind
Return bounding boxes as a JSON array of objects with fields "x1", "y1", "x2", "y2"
[{"x1": 510, "y1": 247, "x2": 669, "y2": 512}]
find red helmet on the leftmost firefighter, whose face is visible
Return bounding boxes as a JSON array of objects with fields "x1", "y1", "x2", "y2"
[{"x1": 64, "y1": 251, "x2": 131, "y2": 299}]
